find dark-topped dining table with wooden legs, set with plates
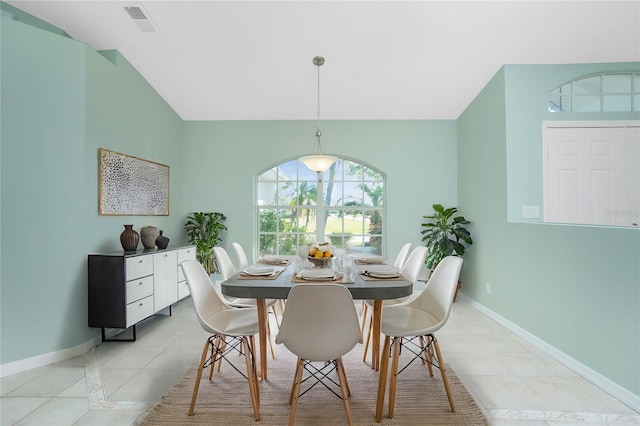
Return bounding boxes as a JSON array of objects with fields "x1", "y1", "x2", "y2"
[{"x1": 220, "y1": 256, "x2": 413, "y2": 380}]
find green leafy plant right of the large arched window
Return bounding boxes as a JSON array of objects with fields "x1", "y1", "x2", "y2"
[{"x1": 421, "y1": 204, "x2": 473, "y2": 269}]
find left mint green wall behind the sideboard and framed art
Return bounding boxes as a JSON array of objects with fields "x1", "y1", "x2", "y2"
[{"x1": 0, "y1": 10, "x2": 185, "y2": 364}]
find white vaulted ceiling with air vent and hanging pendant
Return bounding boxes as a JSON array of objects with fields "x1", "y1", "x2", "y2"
[{"x1": 7, "y1": 0, "x2": 640, "y2": 120}]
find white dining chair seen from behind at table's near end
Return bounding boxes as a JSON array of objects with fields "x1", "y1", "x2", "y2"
[{"x1": 276, "y1": 284, "x2": 362, "y2": 426}]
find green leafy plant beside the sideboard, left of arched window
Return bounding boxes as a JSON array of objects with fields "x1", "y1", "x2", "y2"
[{"x1": 184, "y1": 212, "x2": 227, "y2": 274}]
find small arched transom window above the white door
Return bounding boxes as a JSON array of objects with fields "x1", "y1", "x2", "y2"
[{"x1": 549, "y1": 73, "x2": 640, "y2": 112}]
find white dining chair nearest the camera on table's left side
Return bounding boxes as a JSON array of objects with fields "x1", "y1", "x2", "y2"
[{"x1": 180, "y1": 259, "x2": 260, "y2": 420}]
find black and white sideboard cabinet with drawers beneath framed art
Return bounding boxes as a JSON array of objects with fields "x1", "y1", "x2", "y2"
[{"x1": 88, "y1": 246, "x2": 196, "y2": 341}]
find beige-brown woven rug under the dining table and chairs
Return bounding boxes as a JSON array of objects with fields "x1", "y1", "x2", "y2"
[{"x1": 139, "y1": 341, "x2": 489, "y2": 426}]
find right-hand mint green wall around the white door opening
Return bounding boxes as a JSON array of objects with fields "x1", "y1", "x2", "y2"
[{"x1": 458, "y1": 64, "x2": 640, "y2": 396}]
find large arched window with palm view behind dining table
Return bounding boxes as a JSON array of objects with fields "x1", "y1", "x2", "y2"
[{"x1": 256, "y1": 158, "x2": 385, "y2": 255}]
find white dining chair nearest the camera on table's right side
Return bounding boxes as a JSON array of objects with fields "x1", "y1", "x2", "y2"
[{"x1": 376, "y1": 256, "x2": 462, "y2": 423}]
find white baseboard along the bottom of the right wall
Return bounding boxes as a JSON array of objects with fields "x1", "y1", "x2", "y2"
[{"x1": 458, "y1": 293, "x2": 640, "y2": 410}]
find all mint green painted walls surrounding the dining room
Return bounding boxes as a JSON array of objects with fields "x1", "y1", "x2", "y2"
[{"x1": 0, "y1": 4, "x2": 640, "y2": 404}]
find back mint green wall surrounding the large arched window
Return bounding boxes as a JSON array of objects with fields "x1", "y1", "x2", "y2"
[{"x1": 184, "y1": 120, "x2": 457, "y2": 262}]
